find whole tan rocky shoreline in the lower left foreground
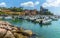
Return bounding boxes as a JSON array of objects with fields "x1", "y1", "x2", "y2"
[{"x1": 0, "y1": 21, "x2": 35, "y2": 38}]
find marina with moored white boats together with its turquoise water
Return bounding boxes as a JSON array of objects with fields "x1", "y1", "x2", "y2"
[{"x1": 0, "y1": 15, "x2": 60, "y2": 38}]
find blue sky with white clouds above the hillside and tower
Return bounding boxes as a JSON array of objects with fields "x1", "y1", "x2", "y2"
[{"x1": 0, "y1": 0, "x2": 60, "y2": 15}]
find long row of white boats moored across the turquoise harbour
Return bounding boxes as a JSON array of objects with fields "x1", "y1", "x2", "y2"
[{"x1": 0, "y1": 15, "x2": 59, "y2": 24}]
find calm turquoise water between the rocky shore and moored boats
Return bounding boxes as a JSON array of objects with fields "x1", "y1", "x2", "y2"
[{"x1": 1, "y1": 20, "x2": 60, "y2": 38}]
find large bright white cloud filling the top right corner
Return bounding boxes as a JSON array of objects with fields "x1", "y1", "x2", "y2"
[{"x1": 42, "y1": 0, "x2": 60, "y2": 7}]
